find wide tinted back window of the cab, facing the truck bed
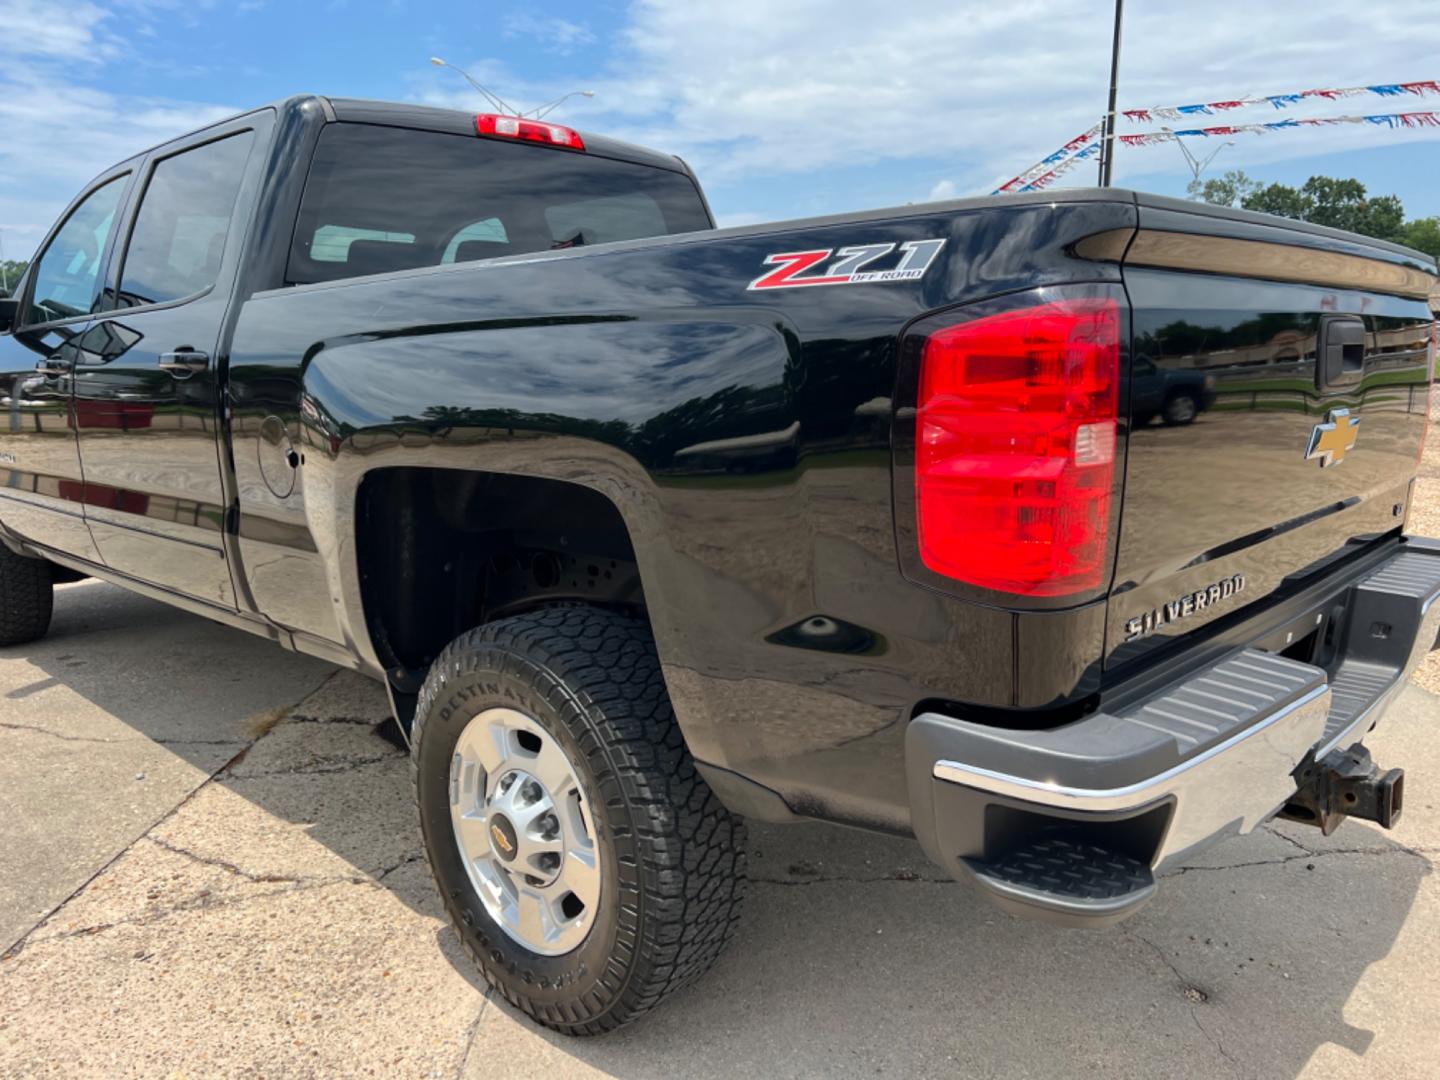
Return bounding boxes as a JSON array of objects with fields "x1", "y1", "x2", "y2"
[{"x1": 287, "y1": 122, "x2": 710, "y2": 285}]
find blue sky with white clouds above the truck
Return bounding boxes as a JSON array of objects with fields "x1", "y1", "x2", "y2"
[{"x1": 0, "y1": 0, "x2": 1440, "y2": 258}]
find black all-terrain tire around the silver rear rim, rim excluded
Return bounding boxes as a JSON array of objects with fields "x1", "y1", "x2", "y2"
[{"x1": 410, "y1": 606, "x2": 746, "y2": 1035}]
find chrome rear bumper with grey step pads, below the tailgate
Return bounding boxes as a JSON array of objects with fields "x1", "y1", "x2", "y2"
[{"x1": 906, "y1": 541, "x2": 1440, "y2": 924}]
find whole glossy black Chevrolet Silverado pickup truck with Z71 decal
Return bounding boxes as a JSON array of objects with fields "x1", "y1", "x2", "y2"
[{"x1": 0, "y1": 96, "x2": 1440, "y2": 1034}]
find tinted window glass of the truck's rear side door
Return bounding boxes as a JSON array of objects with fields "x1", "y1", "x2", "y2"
[{"x1": 118, "y1": 131, "x2": 255, "y2": 307}]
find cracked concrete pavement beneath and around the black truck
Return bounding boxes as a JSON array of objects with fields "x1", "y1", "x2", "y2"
[{"x1": 0, "y1": 583, "x2": 1440, "y2": 1077}]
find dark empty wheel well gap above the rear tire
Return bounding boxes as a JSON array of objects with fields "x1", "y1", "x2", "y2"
[{"x1": 356, "y1": 468, "x2": 645, "y2": 694}]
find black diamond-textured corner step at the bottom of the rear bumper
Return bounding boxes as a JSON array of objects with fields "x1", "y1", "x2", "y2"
[{"x1": 966, "y1": 832, "x2": 1155, "y2": 926}]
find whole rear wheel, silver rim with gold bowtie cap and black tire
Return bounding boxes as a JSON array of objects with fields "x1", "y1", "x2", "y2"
[{"x1": 412, "y1": 608, "x2": 744, "y2": 1034}]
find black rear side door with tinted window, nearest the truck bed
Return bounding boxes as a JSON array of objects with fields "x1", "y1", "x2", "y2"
[{"x1": 73, "y1": 126, "x2": 261, "y2": 608}]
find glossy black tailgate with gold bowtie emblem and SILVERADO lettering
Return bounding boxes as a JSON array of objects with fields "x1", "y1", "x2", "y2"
[{"x1": 1106, "y1": 196, "x2": 1436, "y2": 668}]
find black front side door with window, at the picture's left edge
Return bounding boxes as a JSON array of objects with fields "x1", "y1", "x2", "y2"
[{"x1": 0, "y1": 167, "x2": 131, "y2": 562}]
